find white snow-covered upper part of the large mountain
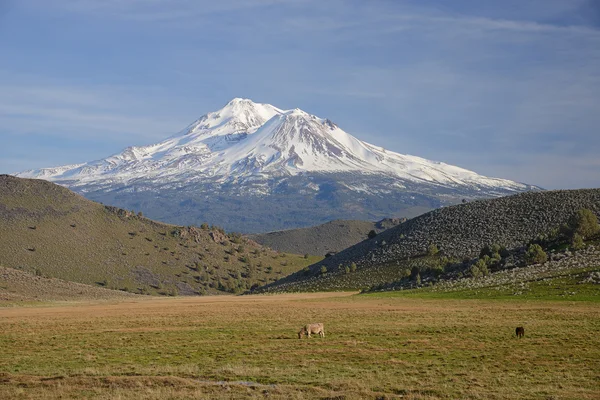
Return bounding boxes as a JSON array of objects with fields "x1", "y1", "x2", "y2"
[{"x1": 16, "y1": 98, "x2": 530, "y2": 194}]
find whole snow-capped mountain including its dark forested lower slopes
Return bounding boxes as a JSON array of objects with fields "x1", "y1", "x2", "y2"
[{"x1": 17, "y1": 98, "x2": 536, "y2": 231}]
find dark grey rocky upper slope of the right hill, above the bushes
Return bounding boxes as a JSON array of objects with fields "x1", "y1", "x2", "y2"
[{"x1": 264, "y1": 189, "x2": 600, "y2": 290}]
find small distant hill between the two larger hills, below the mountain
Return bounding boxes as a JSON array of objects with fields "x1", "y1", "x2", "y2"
[{"x1": 248, "y1": 218, "x2": 406, "y2": 256}]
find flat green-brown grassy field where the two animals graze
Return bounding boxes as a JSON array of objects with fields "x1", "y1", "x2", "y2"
[{"x1": 0, "y1": 293, "x2": 600, "y2": 399}]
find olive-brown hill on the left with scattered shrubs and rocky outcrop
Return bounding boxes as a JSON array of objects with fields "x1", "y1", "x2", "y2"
[{"x1": 0, "y1": 175, "x2": 319, "y2": 295}]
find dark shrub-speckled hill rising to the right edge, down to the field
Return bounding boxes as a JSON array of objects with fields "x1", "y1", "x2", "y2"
[{"x1": 259, "y1": 189, "x2": 600, "y2": 292}]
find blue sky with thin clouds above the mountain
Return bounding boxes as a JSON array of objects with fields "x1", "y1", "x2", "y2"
[{"x1": 0, "y1": 0, "x2": 600, "y2": 189}]
